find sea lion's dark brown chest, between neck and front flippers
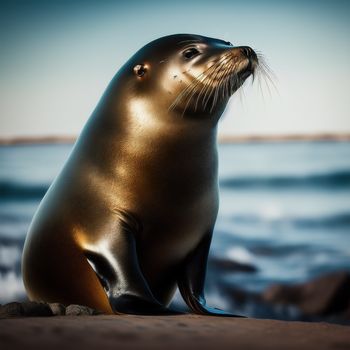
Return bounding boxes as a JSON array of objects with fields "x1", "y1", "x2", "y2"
[{"x1": 115, "y1": 142, "x2": 218, "y2": 259}]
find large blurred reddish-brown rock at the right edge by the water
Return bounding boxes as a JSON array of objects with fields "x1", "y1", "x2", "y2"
[{"x1": 262, "y1": 271, "x2": 350, "y2": 317}]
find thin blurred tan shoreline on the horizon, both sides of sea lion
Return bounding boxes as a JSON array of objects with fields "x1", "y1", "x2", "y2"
[{"x1": 0, "y1": 133, "x2": 350, "y2": 146}]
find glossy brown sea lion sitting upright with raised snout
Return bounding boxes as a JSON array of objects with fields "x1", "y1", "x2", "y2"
[{"x1": 22, "y1": 34, "x2": 258, "y2": 315}]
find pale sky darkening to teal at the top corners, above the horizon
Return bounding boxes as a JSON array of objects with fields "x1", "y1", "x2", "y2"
[{"x1": 0, "y1": 0, "x2": 350, "y2": 137}]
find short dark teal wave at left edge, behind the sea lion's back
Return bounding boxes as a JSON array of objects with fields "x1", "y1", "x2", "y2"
[{"x1": 0, "y1": 180, "x2": 50, "y2": 200}]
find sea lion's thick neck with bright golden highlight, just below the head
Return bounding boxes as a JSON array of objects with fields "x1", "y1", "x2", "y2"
[{"x1": 75, "y1": 101, "x2": 217, "y2": 167}]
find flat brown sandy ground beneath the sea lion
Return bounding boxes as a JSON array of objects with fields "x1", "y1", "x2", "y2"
[{"x1": 0, "y1": 315, "x2": 350, "y2": 350}]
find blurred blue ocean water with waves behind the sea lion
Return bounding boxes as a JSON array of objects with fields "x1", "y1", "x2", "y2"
[{"x1": 0, "y1": 142, "x2": 350, "y2": 316}]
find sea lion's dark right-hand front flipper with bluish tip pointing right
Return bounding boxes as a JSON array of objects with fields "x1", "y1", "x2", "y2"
[{"x1": 178, "y1": 234, "x2": 244, "y2": 317}]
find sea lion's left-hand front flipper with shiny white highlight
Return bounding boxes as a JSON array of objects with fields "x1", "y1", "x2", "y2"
[{"x1": 85, "y1": 211, "x2": 172, "y2": 315}]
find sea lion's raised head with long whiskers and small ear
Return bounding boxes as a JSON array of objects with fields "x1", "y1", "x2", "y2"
[{"x1": 114, "y1": 34, "x2": 258, "y2": 124}]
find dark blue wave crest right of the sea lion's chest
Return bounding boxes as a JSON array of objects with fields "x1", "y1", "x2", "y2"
[{"x1": 220, "y1": 170, "x2": 350, "y2": 188}]
